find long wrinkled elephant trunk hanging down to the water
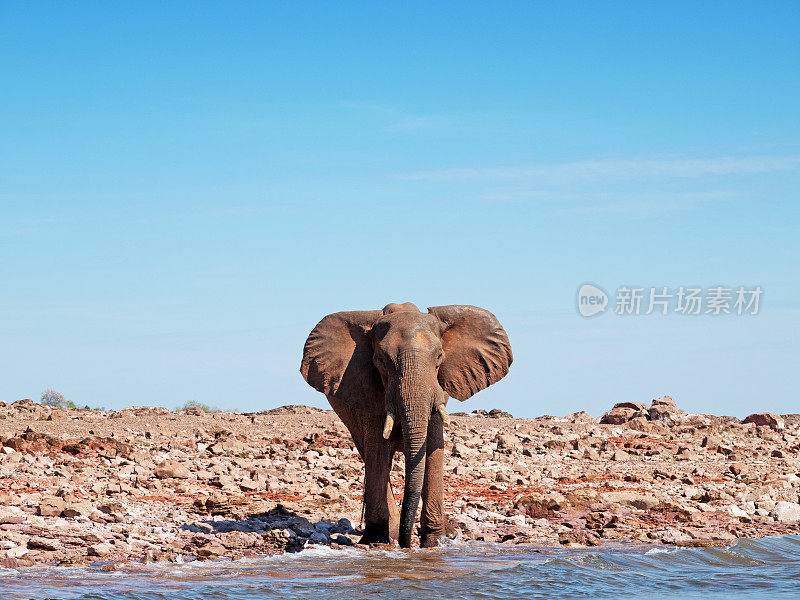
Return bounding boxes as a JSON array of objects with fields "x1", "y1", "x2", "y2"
[{"x1": 398, "y1": 352, "x2": 433, "y2": 548}]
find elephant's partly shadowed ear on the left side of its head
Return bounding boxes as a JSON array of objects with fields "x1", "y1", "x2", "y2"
[{"x1": 300, "y1": 310, "x2": 384, "y2": 413}]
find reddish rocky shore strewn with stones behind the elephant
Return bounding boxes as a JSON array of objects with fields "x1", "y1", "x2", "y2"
[{"x1": 0, "y1": 397, "x2": 800, "y2": 569}]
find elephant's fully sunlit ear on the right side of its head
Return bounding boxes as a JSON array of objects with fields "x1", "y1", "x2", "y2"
[{"x1": 428, "y1": 305, "x2": 514, "y2": 400}]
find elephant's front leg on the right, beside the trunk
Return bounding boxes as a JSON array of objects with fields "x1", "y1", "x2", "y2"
[{"x1": 419, "y1": 413, "x2": 447, "y2": 548}]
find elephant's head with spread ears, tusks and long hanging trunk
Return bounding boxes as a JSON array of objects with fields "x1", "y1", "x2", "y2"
[{"x1": 300, "y1": 303, "x2": 513, "y2": 547}]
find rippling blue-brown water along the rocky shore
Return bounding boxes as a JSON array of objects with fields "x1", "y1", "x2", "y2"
[{"x1": 0, "y1": 535, "x2": 800, "y2": 600}]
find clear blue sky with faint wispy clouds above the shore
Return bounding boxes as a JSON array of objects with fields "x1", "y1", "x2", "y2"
[{"x1": 0, "y1": 2, "x2": 800, "y2": 416}]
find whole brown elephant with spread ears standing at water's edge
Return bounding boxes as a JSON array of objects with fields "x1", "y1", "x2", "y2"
[{"x1": 300, "y1": 302, "x2": 513, "y2": 548}]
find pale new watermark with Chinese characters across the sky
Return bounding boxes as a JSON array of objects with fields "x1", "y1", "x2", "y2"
[{"x1": 578, "y1": 283, "x2": 764, "y2": 317}]
